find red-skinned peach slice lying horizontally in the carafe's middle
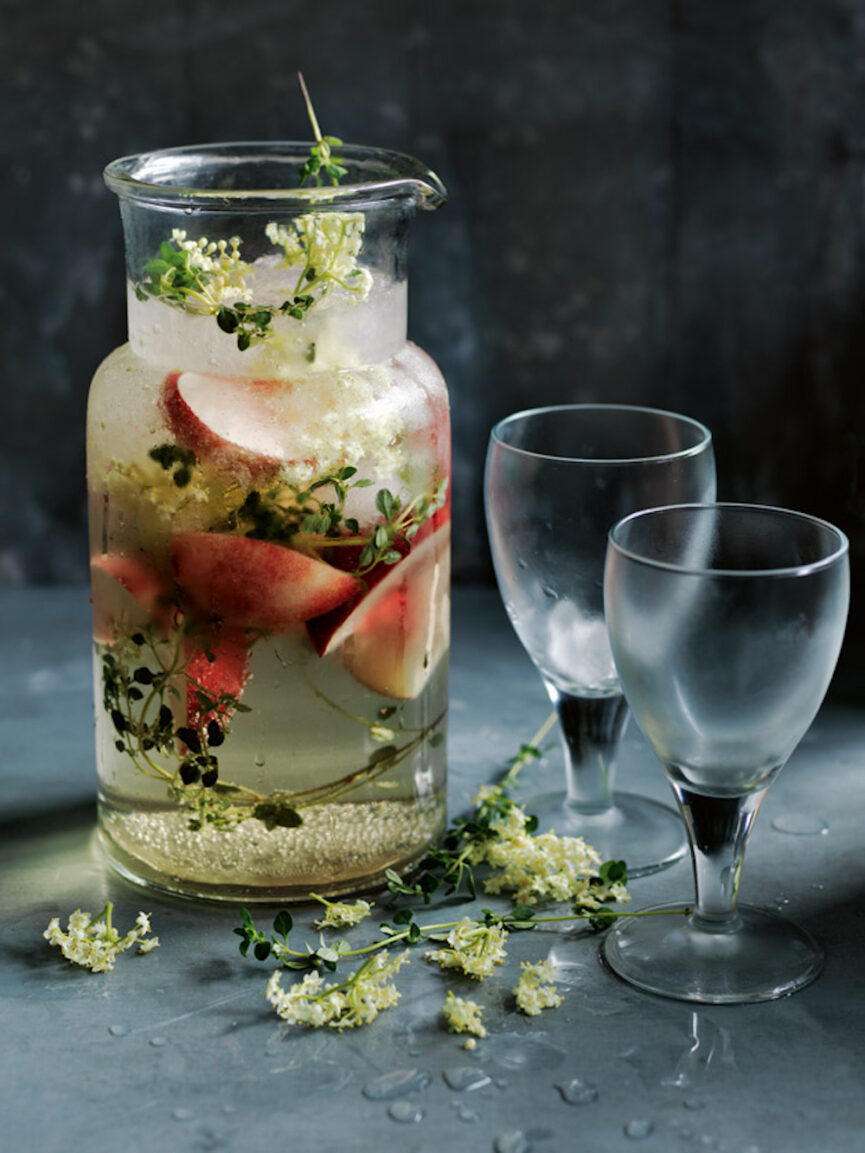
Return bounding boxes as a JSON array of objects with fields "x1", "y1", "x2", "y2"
[{"x1": 172, "y1": 533, "x2": 358, "y2": 632}]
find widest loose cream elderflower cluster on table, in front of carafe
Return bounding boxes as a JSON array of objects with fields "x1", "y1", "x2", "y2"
[{"x1": 265, "y1": 949, "x2": 408, "y2": 1030}]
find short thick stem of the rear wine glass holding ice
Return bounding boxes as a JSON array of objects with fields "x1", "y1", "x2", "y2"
[{"x1": 554, "y1": 692, "x2": 627, "y2": 814}]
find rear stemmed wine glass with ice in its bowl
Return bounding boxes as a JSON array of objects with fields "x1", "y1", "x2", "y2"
[{"x1": 484, "y1": 405, "x2": 715, "y2": 876}]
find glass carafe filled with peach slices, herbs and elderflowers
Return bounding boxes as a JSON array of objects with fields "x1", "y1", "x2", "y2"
[{"x1": 88, "y1": 144, "x2": 450, "y2": 902}]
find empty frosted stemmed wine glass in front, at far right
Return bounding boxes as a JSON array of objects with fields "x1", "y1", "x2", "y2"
[{"x1": 603, "y1": 504, "x2": 850, "y2": 1003}]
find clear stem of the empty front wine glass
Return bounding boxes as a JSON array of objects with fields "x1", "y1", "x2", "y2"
[{"x1": 672, "y1": 782, "x2": 768, "y2": 933}]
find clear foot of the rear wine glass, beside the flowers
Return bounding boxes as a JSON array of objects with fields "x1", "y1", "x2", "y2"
[{"x1": 520, "y1": 792, "x2": 687, "y2": 879}]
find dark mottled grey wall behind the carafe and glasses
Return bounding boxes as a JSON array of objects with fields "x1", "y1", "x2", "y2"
[{"x1": 0, "y1": 0, "x2": 865, "y2": 691}]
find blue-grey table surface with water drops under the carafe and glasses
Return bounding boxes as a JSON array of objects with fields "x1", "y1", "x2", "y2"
[{"x1": 0, "y1": 588, "x2": 865, "y2": 1153}]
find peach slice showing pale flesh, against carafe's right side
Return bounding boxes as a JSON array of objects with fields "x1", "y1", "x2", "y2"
[{"x1": 324, "y1": 522, "x2": 451, "y2": 700}]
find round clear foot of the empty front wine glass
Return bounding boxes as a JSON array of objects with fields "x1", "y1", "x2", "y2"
[{"x1": 601, "y1": 904, "x2": 823, "y2": 1004}]
